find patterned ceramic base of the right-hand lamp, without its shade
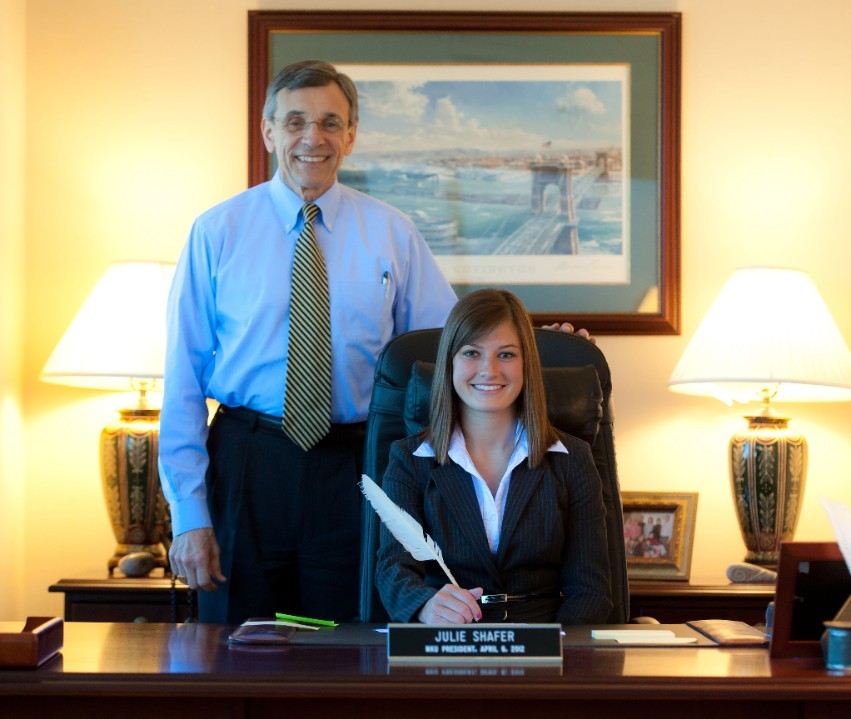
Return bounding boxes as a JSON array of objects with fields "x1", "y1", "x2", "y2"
[{"x1": 730, "y1": 413, "x2": 807, "y2": 567}]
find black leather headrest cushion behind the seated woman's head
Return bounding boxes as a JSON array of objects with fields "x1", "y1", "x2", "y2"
[{"x1": 404, "y1": 360, "x2": 603, "y2": 444}]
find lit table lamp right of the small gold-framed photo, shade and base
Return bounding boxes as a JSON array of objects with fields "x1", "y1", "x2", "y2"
[{"x1": 668, "y1": 267, "x2": 851, "y2": 566}]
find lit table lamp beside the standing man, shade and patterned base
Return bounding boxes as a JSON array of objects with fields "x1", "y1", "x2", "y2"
[{"x1": 40, "y1": 262, "x2": 174, "y2": 576}]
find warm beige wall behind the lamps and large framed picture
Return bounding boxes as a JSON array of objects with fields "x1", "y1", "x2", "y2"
[{"x1": 0, "y1": 0, "x2": 851, "y2": 619}]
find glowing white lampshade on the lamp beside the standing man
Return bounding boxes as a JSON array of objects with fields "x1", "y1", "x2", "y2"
[{"x1": 41, "y1": 262, "x2": 174, "y2": 391}]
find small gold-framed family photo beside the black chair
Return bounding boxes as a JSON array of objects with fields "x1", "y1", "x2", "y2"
[{"x1": 621, "y1": 492, "x2": 697, "y2": 580}]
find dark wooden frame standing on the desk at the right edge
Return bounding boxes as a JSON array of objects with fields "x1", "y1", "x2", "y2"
[{"x1": 769, "y1": 542, "x2": 851, "y2": 657}]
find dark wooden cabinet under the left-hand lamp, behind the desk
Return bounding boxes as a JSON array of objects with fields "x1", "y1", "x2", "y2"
[{"x1": 49, "y1": 577, "x2": 196, "y2": 623}]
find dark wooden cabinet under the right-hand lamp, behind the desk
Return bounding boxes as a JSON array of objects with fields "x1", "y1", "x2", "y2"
[{"x1": 629, "y1": 580, "x2": 774, "y2": 624}]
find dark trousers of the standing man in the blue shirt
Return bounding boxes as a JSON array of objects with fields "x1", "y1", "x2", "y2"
[{"x1": 198, "y1": 407, "x2": 363, "y2": 624}]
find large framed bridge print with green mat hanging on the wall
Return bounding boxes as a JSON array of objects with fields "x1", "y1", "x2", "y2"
[{"x1": 248, "y1": 11, "x2": 681, "y2": 334}]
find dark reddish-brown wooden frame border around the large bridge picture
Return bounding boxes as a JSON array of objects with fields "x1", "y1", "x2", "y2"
[{"x1": 248, "y1": 10, "x2": 682, "y2": 335}]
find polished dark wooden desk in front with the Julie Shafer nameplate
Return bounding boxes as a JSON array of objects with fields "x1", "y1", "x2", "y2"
[{"x1": 0, "y1": 622, "x2": 851, "y2": 719}]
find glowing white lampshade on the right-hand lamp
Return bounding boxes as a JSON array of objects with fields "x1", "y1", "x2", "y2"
[{"x1": 668, "y1": 267, "x2": 851, "y2": 404}]
